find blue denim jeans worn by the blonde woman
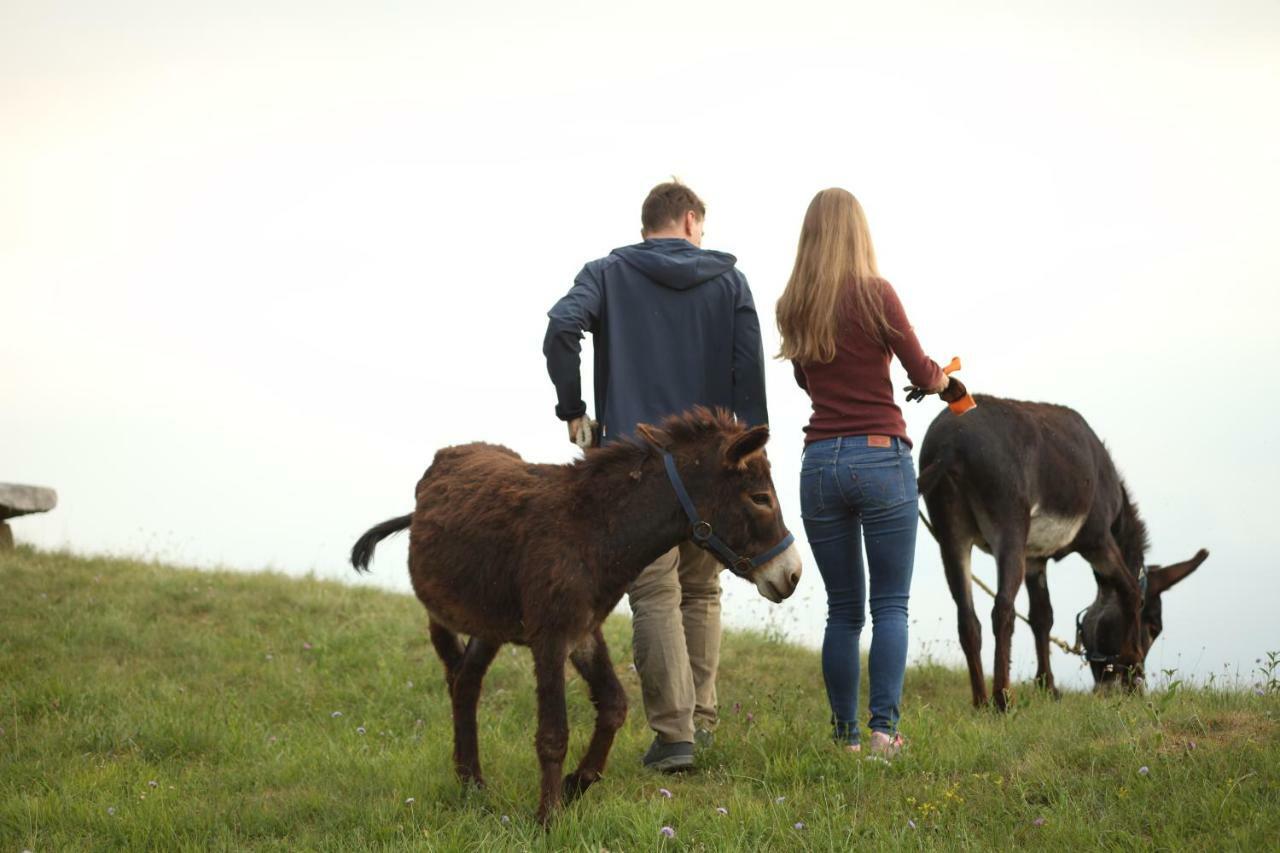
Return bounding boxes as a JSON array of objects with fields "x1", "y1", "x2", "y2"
[{"x1": 800, "y1": 435, "x2": 918, "y2": 744}]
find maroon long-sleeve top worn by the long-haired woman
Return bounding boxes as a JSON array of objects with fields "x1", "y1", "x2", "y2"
[{"x1": 792, "y1": 279, "x2": 943, "y2": 444}]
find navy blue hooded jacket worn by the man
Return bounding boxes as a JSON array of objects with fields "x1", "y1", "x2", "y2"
[{"x1": 543, "y1": 238, "x2": 768, "y2": 441}]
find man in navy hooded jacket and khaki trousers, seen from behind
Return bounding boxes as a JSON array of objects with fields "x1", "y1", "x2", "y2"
[{"x1": 543, "y1": 182, "x2": 768, "y2": 772}]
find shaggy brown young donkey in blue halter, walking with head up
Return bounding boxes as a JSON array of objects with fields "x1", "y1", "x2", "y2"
[{"x1": 351, "y1": 409, "x2": 800, "y2": 822}]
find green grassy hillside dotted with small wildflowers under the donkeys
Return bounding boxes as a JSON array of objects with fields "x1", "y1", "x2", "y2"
[{"x1": 0, "y1": 540, "x2": 1280, "y2": 853}]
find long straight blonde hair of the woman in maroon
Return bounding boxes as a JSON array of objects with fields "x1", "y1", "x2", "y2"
[{"x1": 777, "y1": 187, "x2": 897, "y2": 364}]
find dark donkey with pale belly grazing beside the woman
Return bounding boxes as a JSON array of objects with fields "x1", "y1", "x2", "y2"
[{"x1": 919, "y1": 396, "x2": 1208, "y2": 711}]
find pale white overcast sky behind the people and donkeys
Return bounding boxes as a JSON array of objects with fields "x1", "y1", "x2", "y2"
[{"x1": 0, "y1": 0, "x2": 1280, "y2": 675}]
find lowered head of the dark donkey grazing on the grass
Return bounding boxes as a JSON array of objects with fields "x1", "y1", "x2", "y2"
[{"x1": 1076, "y1": 548, "x2": 1208, "y2": 689}]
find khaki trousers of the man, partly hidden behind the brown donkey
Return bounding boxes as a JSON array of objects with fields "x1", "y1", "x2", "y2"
[{"x1": 628, "y1": 542, "x2": 721, "y2": 743}]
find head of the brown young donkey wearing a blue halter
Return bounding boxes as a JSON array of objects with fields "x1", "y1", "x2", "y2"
[{"x1": 636, "y1": 407, "x2": 801, "y2": 603}]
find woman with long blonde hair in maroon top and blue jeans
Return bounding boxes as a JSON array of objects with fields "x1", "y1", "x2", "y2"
[{"x1": 777, "y1": 190, "x2": 963, "y2": 757}]
